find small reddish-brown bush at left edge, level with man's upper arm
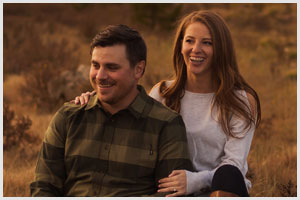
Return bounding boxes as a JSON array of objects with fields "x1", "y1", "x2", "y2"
[{"x1": 3, "y1": 102, "x2": 40, "y2": 151}]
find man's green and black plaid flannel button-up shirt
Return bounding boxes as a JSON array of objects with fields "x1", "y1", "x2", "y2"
[{"x1": 30, "y1": 86, "x2": 192, "y2": 196}]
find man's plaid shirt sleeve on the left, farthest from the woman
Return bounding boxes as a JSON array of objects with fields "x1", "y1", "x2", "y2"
[{"x1": 30, "y1": 108, "x2": 66, "y2": 197}]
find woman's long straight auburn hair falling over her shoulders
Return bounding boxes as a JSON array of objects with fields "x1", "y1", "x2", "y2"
[{"x1": 160, "y1": 11, "x2": 261, "y2": 137}]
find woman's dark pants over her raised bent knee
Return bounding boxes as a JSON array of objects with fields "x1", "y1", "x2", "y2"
[{"x1": 211, "y1": 165, "x2": 249, "y2": 197}]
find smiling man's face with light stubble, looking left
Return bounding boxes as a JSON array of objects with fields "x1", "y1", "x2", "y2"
[{"x1": 90, "y1": 45, "x2": 141, "y2": 111}]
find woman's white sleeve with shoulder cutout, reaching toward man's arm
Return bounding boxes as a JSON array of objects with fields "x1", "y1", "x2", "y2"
[{"x1": 186, "y1": 117, "x2": 255, "y2": 194}]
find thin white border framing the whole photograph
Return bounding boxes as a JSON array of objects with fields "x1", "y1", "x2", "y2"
[{"x1": 0, "y1": 0, "x2": 300, "y2": 199}]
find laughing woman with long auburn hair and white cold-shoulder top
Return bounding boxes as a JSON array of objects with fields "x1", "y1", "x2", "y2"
[{"x1": 76, "y1": 11, "x2": 261, "y2": 196}]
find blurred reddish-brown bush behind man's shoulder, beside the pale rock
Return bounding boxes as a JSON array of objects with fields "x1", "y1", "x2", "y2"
[{"x1": 23, "y1": 37, "x2": 79, "y2": 112}]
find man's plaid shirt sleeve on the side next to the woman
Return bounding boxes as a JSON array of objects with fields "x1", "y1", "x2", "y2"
[{"x1": 155, "y1": 115, "x2": 193, "y2": 195}]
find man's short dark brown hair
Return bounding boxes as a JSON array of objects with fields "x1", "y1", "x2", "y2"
[{"x1": 90, "y1": 24, "x2": 147, "y2": 67}]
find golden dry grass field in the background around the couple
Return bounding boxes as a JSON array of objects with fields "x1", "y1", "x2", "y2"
[{"x1": 3, "y1": 4, "x2": 297, "y2": 197}]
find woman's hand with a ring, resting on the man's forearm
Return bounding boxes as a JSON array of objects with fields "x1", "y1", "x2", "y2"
[{"x1": 157, "y1": 170, "x2": 186, "y2": 197}]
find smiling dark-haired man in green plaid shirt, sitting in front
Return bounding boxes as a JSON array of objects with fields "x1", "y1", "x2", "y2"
[{"x1": 31, "y1": 25, "x2": 191, "y2": 196}]
